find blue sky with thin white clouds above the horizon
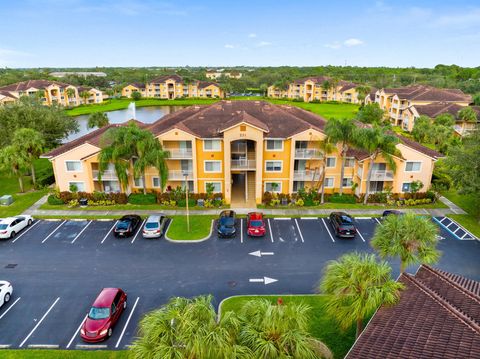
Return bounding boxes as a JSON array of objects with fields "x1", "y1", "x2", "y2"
[{"x1": 0, "y1": 0, "x2": 480, "y2": 68}]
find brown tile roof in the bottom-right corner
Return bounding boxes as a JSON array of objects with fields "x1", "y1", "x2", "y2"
[{"x1": 346, "y1": 265, "x2": 480, "y2": 359}]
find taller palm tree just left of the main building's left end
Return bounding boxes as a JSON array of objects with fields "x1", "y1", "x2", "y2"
[{"x1": 12, "y1": 128, "x2": 45, "y2": 186}]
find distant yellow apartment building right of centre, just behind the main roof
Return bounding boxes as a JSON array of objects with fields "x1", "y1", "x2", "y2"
[{"x1": 267, "y1": 76, "x2": 360, "y2": 103}]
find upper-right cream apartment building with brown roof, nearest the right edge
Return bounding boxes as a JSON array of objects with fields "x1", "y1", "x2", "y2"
[{"x1": 375, "y1": 85, "x2": 472, "y2": 131}]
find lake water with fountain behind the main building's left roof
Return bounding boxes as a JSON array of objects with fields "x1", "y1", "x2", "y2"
[{"x1": 64, "y1": 106, "x2": 184, "y2": 142}]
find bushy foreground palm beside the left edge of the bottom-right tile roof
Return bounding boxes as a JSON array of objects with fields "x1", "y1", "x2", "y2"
[{"x1": 319, "y1": 252, "x2": 403, "y2": 338}]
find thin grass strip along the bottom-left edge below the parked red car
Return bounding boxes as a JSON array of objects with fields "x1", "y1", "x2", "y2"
[{"x1": 0, "y1": 349, "x2": 129, "y2": 359}]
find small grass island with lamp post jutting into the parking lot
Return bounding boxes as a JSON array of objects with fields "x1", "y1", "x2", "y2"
[{"x1": 167, "y1": 216, "x2": 216, "y2": 240}]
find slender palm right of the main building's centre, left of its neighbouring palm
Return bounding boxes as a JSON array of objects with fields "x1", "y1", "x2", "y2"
[{"x1": 325, "y1": 118, "x2": 356, "y2": 195}]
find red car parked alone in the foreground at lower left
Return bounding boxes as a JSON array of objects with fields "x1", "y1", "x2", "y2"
[{"x1": 80, "y1": 288, "x2": 127, "y2": 342}]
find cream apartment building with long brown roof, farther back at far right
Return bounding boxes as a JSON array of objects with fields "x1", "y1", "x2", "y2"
[{"x1": 374, "y1": 85, "x2": 472, "y2": 131}]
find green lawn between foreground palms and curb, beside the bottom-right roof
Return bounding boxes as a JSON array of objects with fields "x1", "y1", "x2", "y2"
[{"x1": 221, "y1": 295, "x2": 355, "y2": 359}]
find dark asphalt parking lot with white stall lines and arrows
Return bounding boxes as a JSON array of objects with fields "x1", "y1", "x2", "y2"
[{"x1": 0, "y1": 217, "x2": 480, "y2": 349}]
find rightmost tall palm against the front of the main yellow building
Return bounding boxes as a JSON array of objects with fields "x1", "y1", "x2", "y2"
[{"x1": 354, "y1": 127, "x2": 399, "y2": 204}]
